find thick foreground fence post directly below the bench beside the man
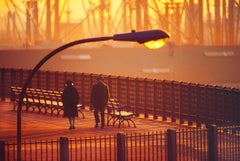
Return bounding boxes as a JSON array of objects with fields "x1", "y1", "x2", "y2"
[{"x1": 117, "y1": 133, "x2": 125, "y2": 161}]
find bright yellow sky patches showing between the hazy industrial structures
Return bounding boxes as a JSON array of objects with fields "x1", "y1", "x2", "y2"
[{"x1": 0, "y1": 0, "x2": 219, "y2": 43}]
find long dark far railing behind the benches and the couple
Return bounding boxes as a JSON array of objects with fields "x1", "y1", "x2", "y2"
[{"x1": 0, "y1": 68, "x2": 240, "y2": 127}]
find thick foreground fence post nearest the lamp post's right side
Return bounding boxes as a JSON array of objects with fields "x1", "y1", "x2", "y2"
[{"x1": 60, "y1": 137, "x2": 69, "y2": 161}]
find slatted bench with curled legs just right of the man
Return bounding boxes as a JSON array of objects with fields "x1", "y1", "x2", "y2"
[{"x1": 107, "y1": 99, "x2": 136, "y2": 127}]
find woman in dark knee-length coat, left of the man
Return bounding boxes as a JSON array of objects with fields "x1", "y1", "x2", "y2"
[{"x1": 62, "y1": 80, "x2": 79, "y2": 130}]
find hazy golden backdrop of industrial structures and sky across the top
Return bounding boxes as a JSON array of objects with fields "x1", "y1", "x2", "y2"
[{"x1": 0, "y1": 0, "x2": 240, "y2": 48}]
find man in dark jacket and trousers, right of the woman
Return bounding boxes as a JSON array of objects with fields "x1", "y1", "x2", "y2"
[{"x1": 91, "y1": 76, "x2": 109, "y2": 128}]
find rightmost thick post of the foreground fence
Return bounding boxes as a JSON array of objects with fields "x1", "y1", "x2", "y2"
[{"x1": 207, "y1": 125, "x2": 218, "y2": 161}]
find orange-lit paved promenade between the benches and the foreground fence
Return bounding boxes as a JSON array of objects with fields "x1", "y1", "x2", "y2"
[{"x1": 0, "y1": 101, "x2": 190, "y2": 140}]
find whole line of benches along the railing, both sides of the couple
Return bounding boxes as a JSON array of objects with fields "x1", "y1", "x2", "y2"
[{"x1": 11, "y1": 86, "x2": 136, "y2": 127}]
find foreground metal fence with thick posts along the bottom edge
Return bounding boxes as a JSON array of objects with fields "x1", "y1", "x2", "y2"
[{"x1": 0, "y1": 125, "x2": 240, "y2": 161}]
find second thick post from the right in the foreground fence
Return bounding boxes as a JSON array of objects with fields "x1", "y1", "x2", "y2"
[{"x1": 167, "y1": 129, "x2": 177, "y2": 161}]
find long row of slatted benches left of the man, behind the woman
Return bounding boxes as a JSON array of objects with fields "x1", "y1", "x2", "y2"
[{"x1": 11, "y1": 86, "x2": 85, "y2": 118}]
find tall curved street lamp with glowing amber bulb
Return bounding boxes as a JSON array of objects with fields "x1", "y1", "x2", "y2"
[{"x1": 17, "y1": 30, "x2": 169, "y2": 161}]
